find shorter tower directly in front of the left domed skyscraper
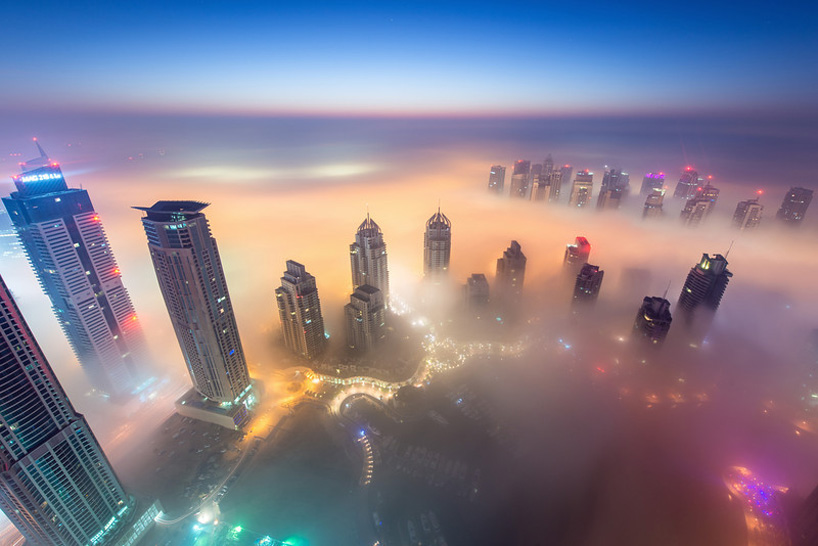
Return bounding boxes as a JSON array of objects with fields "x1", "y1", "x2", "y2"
[{"x1": 344, "y1": 284, "x2": 386, "y2": 351}]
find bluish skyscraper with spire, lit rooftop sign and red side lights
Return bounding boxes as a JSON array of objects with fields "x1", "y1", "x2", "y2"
[{"x1": 3, "y1": 139, "x2": 145, "y2": 397}]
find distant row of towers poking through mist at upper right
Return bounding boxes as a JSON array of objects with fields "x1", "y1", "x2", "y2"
[{"x1": 488, "y1": 160, "x2": 813, "y2": 230}]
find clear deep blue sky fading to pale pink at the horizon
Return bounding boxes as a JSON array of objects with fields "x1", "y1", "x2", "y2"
[{"x1": 0, "y1": 0, "x2": 818, "y2": 116}]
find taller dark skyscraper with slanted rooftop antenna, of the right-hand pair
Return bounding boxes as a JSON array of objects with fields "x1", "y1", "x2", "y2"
[{"x1": 676, "y1": 254, "x2": 733, "y2": 339}]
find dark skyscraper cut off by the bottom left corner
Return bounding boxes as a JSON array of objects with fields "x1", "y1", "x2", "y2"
[{"x1": 0, "y1": 274, "x2": 135, "y2": 546}]
